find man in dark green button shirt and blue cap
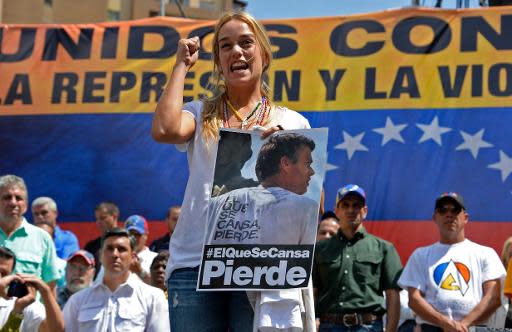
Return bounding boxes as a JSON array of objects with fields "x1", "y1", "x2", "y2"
[{"x1": 313, "y1": 184, "x2": 402, "y2": 332}]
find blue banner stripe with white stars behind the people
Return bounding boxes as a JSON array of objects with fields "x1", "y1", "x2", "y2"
[{"x1": 0, "y1": 108, "x2": 512, "y2": 221}]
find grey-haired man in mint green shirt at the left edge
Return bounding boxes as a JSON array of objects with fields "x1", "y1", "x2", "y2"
[{"x1": 0, "y1": 175, "x2": 60, "y2": 291}]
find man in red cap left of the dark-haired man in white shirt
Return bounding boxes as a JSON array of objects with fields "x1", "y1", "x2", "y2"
[{"x1": 57, "y1": 250, "x2": 96, "y2": 309}]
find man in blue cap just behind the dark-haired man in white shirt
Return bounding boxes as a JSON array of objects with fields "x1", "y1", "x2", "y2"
[{"x1": 124, "y1": 215, "x2": 158, "y2": 283}]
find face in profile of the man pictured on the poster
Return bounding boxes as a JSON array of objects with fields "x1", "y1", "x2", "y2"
[{"x1": 285, "y1": 146, "x2": 315, "y2": 195}]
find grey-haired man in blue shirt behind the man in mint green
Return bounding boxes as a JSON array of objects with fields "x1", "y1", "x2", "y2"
[{"x1": 32, "y1": 197, "x2": 80, "y2": 259}]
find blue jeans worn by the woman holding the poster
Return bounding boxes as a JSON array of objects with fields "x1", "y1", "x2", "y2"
[{"x1": 167, "y1": 268, "x2": 254, "y2": 332}]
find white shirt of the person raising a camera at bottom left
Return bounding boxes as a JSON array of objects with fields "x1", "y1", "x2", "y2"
[{"x1": 0, "y1": 297, "x2": 46, "y2": 332}]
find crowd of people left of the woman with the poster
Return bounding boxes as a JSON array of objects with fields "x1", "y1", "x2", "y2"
[{"x1": 0, "y1": 175, "x2": 174, "y2": 332}]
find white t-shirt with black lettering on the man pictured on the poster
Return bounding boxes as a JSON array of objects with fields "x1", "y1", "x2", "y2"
[{"x1": 208, "y1": 186, "x2": 318, "y2": 244}]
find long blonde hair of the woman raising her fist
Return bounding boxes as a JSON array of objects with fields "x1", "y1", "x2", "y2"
[{"x1": 201, "y1": 12, "x2": 272, "y2": 142}]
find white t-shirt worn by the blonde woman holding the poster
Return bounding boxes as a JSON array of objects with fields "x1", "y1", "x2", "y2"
[{"x1": 166, "y1": 101, "x2": 310, "y2": 279}]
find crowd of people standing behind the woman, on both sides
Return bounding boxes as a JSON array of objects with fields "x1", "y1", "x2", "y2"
[{"x1": 0, "y1": 175, "x2": 512, "y2": 332}]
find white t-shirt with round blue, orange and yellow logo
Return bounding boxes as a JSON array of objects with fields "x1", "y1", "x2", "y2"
[{"x1": 398, "y1": 239, "x2": 505, "y2": 324}]
